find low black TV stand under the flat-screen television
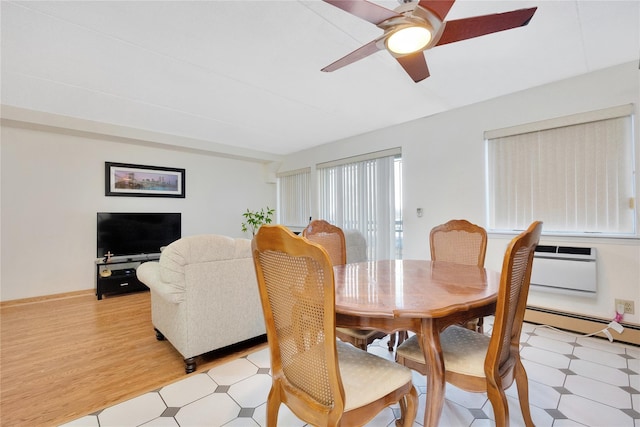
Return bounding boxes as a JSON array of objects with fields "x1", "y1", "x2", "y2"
[{"x1": 96, "y1": 254, "x2": 160, "y2": 300}]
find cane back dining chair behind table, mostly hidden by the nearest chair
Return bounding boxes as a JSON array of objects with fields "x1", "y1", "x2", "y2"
[{"x1": 302, "y1": 219, "x2": 393, "y2": 350}]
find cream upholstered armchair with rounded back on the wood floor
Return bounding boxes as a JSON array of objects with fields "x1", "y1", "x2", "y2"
[{"x1": 137, "y1": 235, "x2": 266, "y2": 373}]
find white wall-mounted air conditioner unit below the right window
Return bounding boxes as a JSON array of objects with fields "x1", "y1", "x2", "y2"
[{"x1": 531, "y1": 245, "x2": 597, "y2": 296}]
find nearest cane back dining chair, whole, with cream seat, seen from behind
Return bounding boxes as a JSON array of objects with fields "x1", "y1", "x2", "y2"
[{"x1": 252, "y1": 225, "x2": 418, "y2": 427}]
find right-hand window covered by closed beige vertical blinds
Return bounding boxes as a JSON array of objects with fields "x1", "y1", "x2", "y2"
[{"x1": 485, "y1": 105, "x2": 636, "y2": 235}]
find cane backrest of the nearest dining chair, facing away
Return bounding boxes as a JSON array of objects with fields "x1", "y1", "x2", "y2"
[{"x1": 252, "y1": 225, "x2": 344, "y2": 425}]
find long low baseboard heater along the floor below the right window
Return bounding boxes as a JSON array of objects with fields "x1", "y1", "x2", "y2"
[{"x1": 524, "y1": 306, "x2": 640, "y2": 346}]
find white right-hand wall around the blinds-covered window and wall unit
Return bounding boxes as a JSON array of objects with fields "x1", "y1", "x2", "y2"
[{"x1": 280, "y1": 61, "x2": 640, "y2": 323}]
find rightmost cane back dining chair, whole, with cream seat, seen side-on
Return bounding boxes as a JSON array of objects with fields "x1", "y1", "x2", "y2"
[{"x1": 396, "y1": 221, "x2": 542, "y2": 427}]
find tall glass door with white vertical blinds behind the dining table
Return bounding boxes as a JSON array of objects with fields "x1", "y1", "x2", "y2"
[{"x1": 318, "y1": 149, "x2": 402, "y2": 260}]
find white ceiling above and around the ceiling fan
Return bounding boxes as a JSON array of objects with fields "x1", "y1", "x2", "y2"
[{"x1": 0, "y1": 0, "x2": 640, "y2": 154}]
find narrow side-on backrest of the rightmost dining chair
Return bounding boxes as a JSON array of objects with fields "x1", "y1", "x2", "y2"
[{"x1": 484, "y1": 221, "x2": 542, "y2": 377}]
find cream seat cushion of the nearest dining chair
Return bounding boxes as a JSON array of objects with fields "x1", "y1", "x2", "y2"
[{"x1": 336, "y1": 341, "x2": 411, "y2": 411}]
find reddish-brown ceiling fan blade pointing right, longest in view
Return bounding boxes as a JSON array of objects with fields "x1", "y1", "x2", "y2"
[{"x1": 436, "y1": 7, "x2": 537, "y2": 46}]
